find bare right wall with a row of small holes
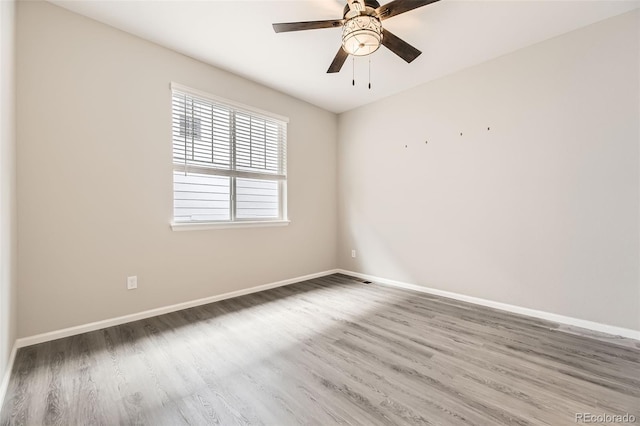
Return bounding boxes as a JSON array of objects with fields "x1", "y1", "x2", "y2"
[{"x1": 338, "y1": 11, "x2": 640, "y2": 330}]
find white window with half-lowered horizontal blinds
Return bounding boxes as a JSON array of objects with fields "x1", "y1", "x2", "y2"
[{"x1": 171, "y1": 83, "x2": 288, "y2": 230}]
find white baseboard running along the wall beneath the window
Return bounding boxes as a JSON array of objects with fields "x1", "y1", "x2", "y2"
[{"x1": 15, "y1": 269, "x2": 338, "y2": 348}]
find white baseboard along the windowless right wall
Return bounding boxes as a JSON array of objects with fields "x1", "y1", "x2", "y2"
[{"x1": 338, "y1": 269, "x2": 640, "y2": 340}]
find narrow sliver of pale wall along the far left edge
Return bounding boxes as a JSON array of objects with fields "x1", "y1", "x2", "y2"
[{"x1": 0, "y1": 1, "x2": 18, "y2": 392}]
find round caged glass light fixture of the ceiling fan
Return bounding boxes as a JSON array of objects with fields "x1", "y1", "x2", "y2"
[{"x1": 342, "y1": 15, "x2": 382, "y2": 56}]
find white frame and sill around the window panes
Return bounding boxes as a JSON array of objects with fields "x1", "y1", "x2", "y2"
[{"x1": 169, "y1": 82, "x2": 290, "y2": 231}]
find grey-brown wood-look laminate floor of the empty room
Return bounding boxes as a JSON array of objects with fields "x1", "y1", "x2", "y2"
[{"x1": 0, "y1": 275, "x2": 640, "y2": 426}]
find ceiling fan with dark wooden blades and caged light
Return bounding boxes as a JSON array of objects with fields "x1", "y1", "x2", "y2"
[{"x1": 273, "y1": 0, "x2": 439, "y2": 73}]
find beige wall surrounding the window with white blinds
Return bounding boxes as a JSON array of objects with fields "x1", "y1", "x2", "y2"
[{"x1": 17, "y1": 2, "x2": 337, "y2": 337}]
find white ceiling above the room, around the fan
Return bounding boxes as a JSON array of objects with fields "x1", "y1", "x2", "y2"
[{"x1": 50, "y1": 0, "x2": 640, "y2": 113}]
